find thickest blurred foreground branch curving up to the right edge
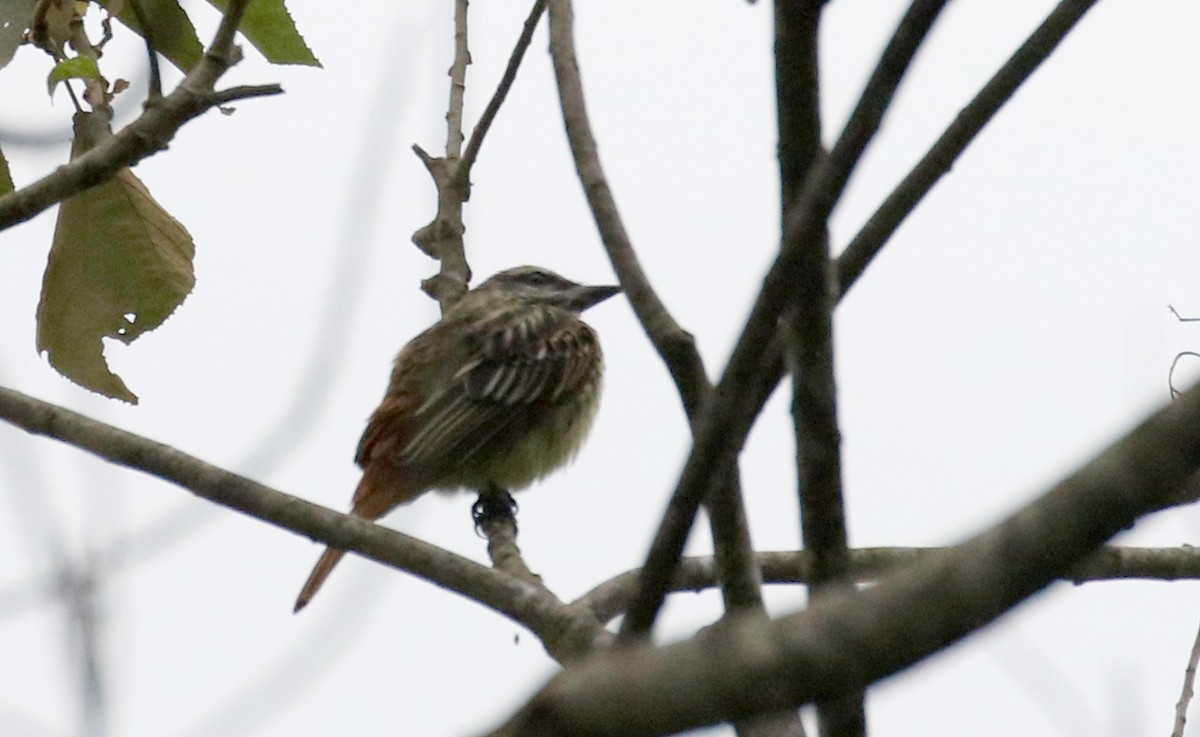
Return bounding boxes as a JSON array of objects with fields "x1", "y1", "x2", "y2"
[{"x1": 492, "y1": 387, "x2": 1200, "y2": 737}]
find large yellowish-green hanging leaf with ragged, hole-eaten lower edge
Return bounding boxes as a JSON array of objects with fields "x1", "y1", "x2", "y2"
[{"x1": 37, "y1": 113, "x2": 196, "y2": 405}]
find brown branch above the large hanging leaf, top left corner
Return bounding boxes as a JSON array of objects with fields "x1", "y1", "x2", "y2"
[{"x1": 0, "y1": 0, "x2": 273, "y2": 230}]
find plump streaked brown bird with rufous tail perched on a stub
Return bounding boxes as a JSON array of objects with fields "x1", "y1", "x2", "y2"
[{"x1": 294, "y1": 266, "x2": 620, "y2": 612}]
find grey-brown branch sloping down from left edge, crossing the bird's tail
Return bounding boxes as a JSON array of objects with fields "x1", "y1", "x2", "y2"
[{"x1": 0, "y1": 389, "x2": 607, "y2": 660}]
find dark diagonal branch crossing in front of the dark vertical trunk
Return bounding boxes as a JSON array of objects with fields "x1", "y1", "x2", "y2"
[{"x1": 619, "y1": 0, "x2": 947, "y2": 639}]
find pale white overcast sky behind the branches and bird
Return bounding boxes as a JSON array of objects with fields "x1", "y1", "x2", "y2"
[{"x1": 0, "y1": 0, "x2": 1200, "y2": 737}]
